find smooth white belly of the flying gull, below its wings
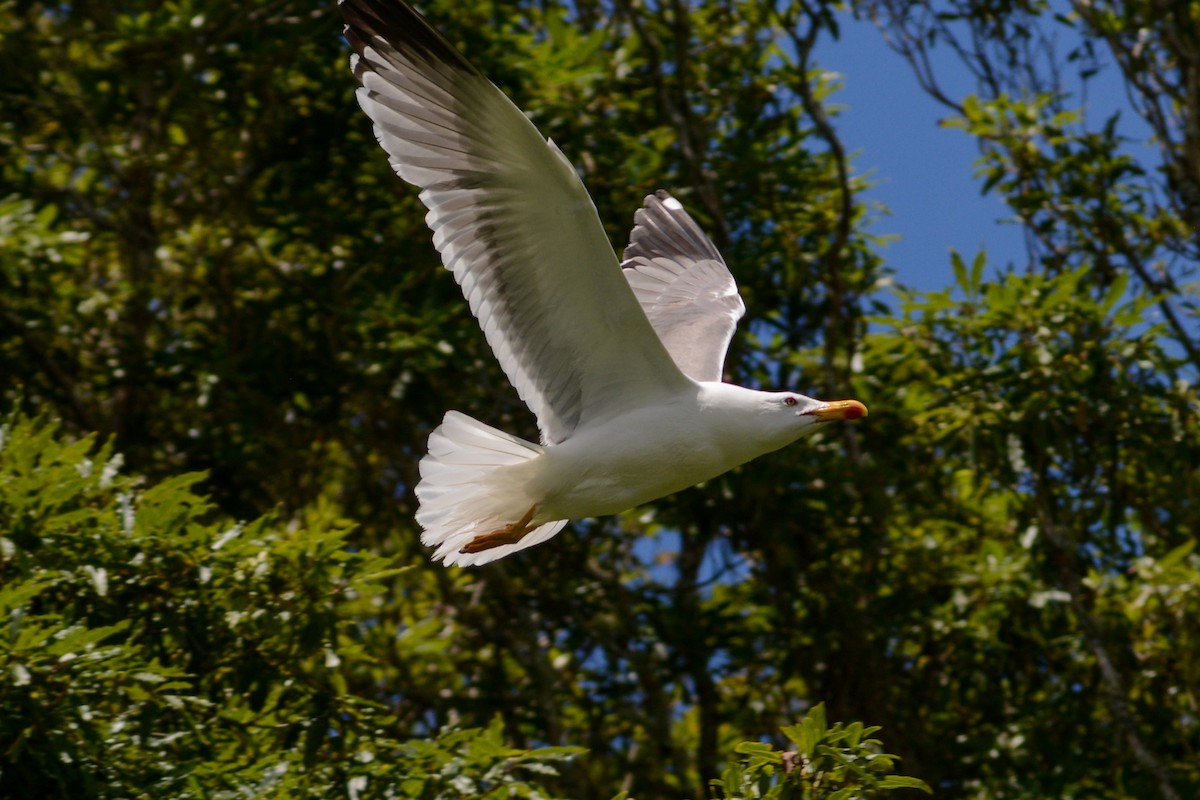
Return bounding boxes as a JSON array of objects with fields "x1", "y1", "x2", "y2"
[{"x1": 536, "y1": 415, "x2": 745, "y2": 519}]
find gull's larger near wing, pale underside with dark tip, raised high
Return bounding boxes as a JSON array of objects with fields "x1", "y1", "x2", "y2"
[{"x1": 340, "y1": 0, "x2": 688, "y2": 444}]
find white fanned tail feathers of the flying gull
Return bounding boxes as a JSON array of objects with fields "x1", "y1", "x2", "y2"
[{"x1": 416, "y1": 411, "x2": 566, "y2": 566}]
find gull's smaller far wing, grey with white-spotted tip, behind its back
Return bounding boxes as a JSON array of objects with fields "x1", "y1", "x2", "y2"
[{"x1": 622, "y1": 190, "x2": 746, "y2": 380}]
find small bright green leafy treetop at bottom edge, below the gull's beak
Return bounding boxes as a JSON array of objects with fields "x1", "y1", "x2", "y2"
[{"x1": 712, "y1": 704, "x2": 932, "y2": 800}]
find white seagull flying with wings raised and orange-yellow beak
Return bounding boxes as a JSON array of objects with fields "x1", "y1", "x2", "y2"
[{"x1": 338, "y1": 0, "x2": 866, "y2": 566}]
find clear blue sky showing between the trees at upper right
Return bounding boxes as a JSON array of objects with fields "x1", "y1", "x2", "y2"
[{"x1": 817, "y1": 14, "x2": 1154, "y2": 290}]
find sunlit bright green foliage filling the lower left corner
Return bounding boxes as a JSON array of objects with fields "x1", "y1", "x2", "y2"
[{"x1": 0, "y1": 417, "x2": 578, "y2": 798}]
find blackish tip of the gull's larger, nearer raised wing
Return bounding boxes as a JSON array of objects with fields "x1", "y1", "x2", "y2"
[{"x1": 337, "y1": 0, "x2": 480, "y2": 76}]
